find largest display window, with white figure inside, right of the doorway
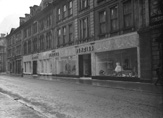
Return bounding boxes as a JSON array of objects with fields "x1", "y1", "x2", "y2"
[{"x1": 96, "y1": 48, "x2": 138, "y2": 77}]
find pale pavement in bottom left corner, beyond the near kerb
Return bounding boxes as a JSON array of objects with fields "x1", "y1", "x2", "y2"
[{"x1": 0, "y1": 93, "x2": 45, "y2": 118}]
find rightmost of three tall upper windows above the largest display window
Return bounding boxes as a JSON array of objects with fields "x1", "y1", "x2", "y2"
[{"x1": 123, "y1": 0, "x2": 132, "y2": 28}]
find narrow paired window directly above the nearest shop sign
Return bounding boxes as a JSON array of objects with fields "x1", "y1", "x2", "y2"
[{"x1": 80, "y1": 17, "x2": 88, "y2": 39}]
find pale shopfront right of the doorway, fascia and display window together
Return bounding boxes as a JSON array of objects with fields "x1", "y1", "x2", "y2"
[{"x1": 92, "y1": 32, "x2": 141, "y2": 79}]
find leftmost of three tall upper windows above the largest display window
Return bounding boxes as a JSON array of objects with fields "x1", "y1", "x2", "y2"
[{"x1": 99, "y1": 11, "x2": 106, "y2": 34}]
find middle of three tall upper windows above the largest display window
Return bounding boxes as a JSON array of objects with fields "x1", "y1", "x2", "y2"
[{"x1": 110, "y1": 6, "x2": 118, "y2": 31}]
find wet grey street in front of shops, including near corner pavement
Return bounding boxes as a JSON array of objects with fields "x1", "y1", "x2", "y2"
[{"x1": 0, "y1": 75, "x2": 163, "y2": 118}]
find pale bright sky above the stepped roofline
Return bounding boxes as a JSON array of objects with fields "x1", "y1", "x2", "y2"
[{"x1": 0, "y1": 0, "x2": 41, "y2": 34}]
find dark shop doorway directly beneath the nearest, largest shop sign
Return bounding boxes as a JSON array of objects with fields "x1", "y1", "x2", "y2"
[{"x1": 79, "y1": 54, "x2": 91, "y2": 77}]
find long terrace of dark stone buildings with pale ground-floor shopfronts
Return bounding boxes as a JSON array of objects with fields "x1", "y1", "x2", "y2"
[{"x1": 6, "y1": 0, "x2": 163, "y2": 82}]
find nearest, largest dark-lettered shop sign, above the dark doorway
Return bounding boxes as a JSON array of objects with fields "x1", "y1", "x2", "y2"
[{"x1": 76, "y1": 45, "x2": 94, "y2": 54}]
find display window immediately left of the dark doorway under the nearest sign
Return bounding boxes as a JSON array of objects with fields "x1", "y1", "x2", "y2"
[{"x1": 58, "y1": 56, "x2": 76, "y2": 75}]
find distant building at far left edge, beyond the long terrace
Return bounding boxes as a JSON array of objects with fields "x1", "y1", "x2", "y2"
[{"x1": 0, "y1": 34, "x2": 6, "y2": 72}]
